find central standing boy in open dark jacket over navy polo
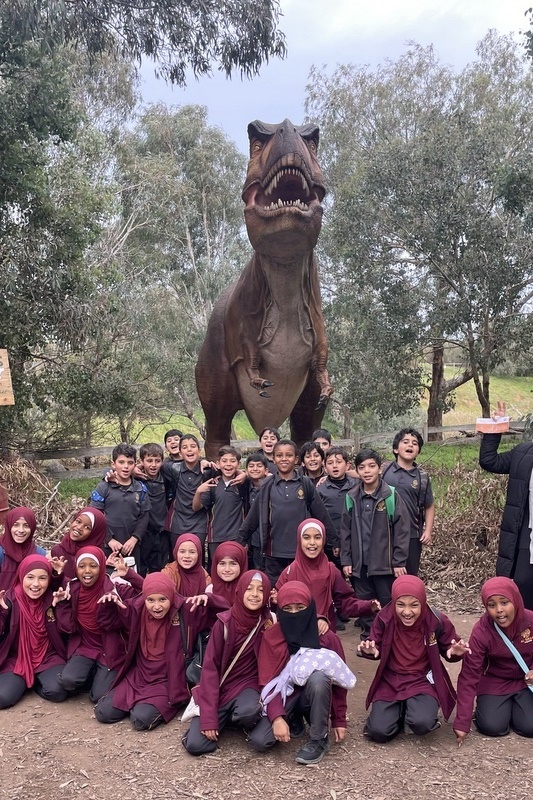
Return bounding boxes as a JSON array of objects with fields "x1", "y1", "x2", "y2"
[{"x1": 239, "y1": 439, "x2": 338, "y2": 586}]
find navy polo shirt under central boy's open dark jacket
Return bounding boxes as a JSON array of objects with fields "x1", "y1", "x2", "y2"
[{"x1": 269, "y1": 472, "x2": 309, "y2": 558}]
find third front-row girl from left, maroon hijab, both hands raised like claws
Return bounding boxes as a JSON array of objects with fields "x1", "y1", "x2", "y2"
[{"x1": 94, "y1": 572, "x2": 228, "y2": 731}]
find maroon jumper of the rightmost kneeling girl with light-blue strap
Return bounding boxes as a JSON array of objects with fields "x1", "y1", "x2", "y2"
[{"x1": 453, "y1": 608, "x2": 533, "y2": 733}]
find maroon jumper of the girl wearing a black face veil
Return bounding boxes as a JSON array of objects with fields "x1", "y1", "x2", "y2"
[{"x1": 258, "y1": 622, "x2": 348, "y2": 728}]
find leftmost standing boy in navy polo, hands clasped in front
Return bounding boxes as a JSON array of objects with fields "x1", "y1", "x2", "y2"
[{"x1": 89, "y1": 443, "x2": 151, "y2": 565}]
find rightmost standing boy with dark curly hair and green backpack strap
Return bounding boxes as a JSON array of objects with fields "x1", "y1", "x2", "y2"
[{"x1": 382, "y1": 428, "x2": 435, "y2": 575}]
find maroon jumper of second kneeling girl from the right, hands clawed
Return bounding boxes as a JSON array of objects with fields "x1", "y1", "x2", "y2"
[{"x1": 366, "y1": 603, "x2": 461, "y2": 719}]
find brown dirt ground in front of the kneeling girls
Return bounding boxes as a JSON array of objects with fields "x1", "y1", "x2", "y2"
[{"x1": 0, "y1": 614, "x2": 533, "y2": 800}]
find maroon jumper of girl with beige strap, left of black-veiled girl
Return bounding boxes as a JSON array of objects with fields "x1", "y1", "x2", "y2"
[{"x1": 193, "y1": 610, "x2": 272, "y2": 731}]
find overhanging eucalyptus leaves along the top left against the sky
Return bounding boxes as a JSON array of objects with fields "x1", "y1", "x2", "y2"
[{"x1": 0, "y1": 0, "x2": 286, "y2": 86}]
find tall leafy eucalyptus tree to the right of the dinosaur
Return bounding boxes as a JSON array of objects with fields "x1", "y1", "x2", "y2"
[{"x1": 307, "y1": 32, "x2": 533, "y2": 424}]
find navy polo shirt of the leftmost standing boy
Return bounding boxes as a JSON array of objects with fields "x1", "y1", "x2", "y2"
[{"x1": 89, "y1": 478, "x2": 151, "y2": 544}]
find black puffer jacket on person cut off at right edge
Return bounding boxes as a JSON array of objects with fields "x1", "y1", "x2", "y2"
[{"x1": 479, "y1": 433, "x2": 533, "y2": 578}]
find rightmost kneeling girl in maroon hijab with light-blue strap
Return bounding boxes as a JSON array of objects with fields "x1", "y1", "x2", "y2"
[{"x1": 453, "y1": 578, "x2": 533, "y2": 745}]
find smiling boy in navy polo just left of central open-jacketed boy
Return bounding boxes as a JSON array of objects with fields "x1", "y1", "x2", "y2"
[{"x1": 192, "y1": 445, "x2": 248, "y2": 563}]
